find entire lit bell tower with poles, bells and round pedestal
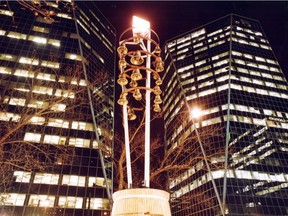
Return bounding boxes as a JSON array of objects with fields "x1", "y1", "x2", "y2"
[{"x1": 111, "y1": 16, "x2": 171, "y2": 216}]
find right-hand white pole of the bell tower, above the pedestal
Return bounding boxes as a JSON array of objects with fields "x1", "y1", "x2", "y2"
[{"x1": 144, "y1": 29, "x2": 151, "y2": 188}]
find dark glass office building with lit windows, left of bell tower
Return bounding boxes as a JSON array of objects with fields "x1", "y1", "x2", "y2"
[{"x1": 0, "y1": 1, "x2": 116, "y2": 216}]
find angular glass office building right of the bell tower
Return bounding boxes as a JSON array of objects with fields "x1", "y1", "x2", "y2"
[{"x1": 163, "y1": 15, "x2": 288, "y2": 216}]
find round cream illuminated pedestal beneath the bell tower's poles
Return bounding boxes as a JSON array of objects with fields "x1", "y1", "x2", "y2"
[{"x1": 112, "y1": 188, "x2": 171, "y2": 216}]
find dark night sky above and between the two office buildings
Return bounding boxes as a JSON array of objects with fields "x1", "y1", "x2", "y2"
[{"x1": 95, "y1": 1, "x2": 288, "y2": 77}]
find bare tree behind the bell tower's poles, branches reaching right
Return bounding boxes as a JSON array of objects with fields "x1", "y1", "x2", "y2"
[{"x1": 114, "y1": 109, "x2": 224, "y2": 190}]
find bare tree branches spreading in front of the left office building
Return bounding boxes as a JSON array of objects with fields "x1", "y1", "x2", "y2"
[{"x1": 0, "y1": 55, "x2": 112, "y2": 203}]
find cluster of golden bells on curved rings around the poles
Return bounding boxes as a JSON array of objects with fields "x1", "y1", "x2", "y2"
[{"x1": 117, "y1": 29, "x2": 164, "y2": 120}]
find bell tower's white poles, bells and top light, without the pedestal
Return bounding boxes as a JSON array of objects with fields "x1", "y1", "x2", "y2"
[{"x1": 117, "y1": 16, "x2": 164, "y2": 188}]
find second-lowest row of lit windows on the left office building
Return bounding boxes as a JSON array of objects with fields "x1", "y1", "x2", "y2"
[{"x1": 13, "y1": 171, "x2": 112, "y2": 187}]
